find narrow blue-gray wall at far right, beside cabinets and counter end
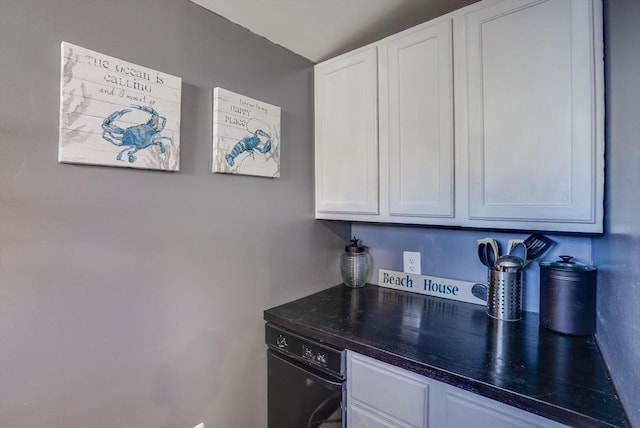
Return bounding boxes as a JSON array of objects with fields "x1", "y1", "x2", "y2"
[{"x1": 593, "y1": 0, "x2": 640, "y2": 427}]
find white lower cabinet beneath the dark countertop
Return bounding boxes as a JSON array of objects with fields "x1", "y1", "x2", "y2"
[{"x1": 347, "y1": 351, "x2": 566, "y2": 428}]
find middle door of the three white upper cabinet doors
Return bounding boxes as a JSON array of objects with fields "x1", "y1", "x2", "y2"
[{"x1": 380, "y1": 19, "x2": 454, "y2": 217}]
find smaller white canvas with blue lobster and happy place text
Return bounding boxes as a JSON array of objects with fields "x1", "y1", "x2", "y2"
[{"x1": 212, "y1": 88, "x2": 280, "y2": 178}]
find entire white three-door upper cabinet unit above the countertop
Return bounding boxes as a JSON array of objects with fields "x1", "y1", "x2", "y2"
[{"x1": 315, "y1": 0, "x2": 604, "y2": 233}]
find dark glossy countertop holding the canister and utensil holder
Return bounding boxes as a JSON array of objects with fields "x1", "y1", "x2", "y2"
[{"x1": 264, "y1": 285, "x2": 628, "y2": 427}]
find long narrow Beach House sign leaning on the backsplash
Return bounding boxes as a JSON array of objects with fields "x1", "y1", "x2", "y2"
[{"x1": 378, "y1": 269, "x2": 487, "y2": 305}]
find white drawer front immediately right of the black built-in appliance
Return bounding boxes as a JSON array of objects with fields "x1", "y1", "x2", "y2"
[{"x1": 347, "y1": 356, "x2": 429, "y2": 427}]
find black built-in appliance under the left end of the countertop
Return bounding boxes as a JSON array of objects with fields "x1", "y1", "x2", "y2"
[{"x1": 266, "y1": 323, "x2": 346, "y2": 428}]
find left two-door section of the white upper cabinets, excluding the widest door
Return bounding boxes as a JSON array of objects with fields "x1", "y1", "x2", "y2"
[{"x1": 315, "y1": 19, "x2": 454, "y2": 224}]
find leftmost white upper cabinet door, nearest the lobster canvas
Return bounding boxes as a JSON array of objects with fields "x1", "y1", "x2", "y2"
[{"x1": 315, "y1": 46, "x2": 378, "y2": 218}]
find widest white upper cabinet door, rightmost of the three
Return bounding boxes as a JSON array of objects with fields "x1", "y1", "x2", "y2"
[{"x1": 455, "y1": 0, "x2": 604, "y2": 232}]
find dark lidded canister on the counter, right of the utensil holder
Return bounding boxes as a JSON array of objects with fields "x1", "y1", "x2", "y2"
[{"x1": 540, "y1": 256, "x2": 598, "y2": 336}]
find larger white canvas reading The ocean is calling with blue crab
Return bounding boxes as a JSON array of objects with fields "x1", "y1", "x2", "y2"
[{"x1": 58, "y1": 42, "x2": 182, "y2": 171}]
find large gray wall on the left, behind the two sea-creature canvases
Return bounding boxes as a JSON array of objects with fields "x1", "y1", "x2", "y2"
[{"x1": 0, "y1": 0, "x2": 343, "y2": 428}]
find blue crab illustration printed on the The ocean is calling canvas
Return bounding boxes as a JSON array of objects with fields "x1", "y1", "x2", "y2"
[{"x1": 102, "y1": 104, "x2": 173, "y2": 163}]
